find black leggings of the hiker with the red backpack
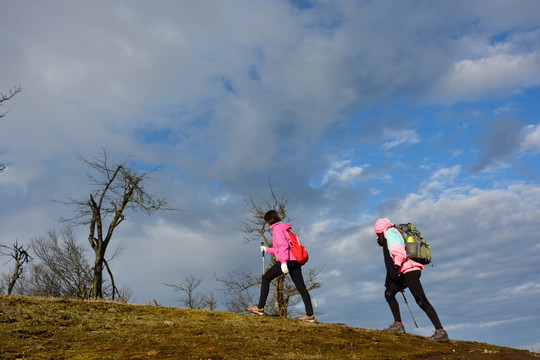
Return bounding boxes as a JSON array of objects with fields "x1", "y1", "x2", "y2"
[{"x1": 258, "y1": 261, "x2": 313, "y2": 316}]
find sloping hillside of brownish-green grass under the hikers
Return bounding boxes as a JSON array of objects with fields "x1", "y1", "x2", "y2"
[{"x1": 0, "y1": 296, "x2": 540, "y2": 360}]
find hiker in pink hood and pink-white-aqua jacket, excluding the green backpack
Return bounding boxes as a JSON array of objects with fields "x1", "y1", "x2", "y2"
[{"x1": 374, "y1": 219, "x2": 449, "y2": 342}]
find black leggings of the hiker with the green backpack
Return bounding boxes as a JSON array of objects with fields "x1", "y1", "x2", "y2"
[{"x1": 384, "y1": 270, "x2": 442, "y2": 329}]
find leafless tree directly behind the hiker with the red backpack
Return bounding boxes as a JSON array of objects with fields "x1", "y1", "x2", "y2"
[{"x1": 217, "y1": 180, "x2": 322, "y2": 316}]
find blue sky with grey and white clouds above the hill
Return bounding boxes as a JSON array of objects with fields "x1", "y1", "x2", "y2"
[{"x1": 0, "y1": 0, "x2": 540, "y2": 351}]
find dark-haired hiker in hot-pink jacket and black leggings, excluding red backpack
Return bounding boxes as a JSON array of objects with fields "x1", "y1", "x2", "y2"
[{"x1": 247, "y1": 210, "x2": 317, "y2": 322}]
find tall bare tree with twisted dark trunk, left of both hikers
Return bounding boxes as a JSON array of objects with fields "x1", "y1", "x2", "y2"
[{"x1": 58, "y1": 150, "x2": 172, "y2": 299}]
